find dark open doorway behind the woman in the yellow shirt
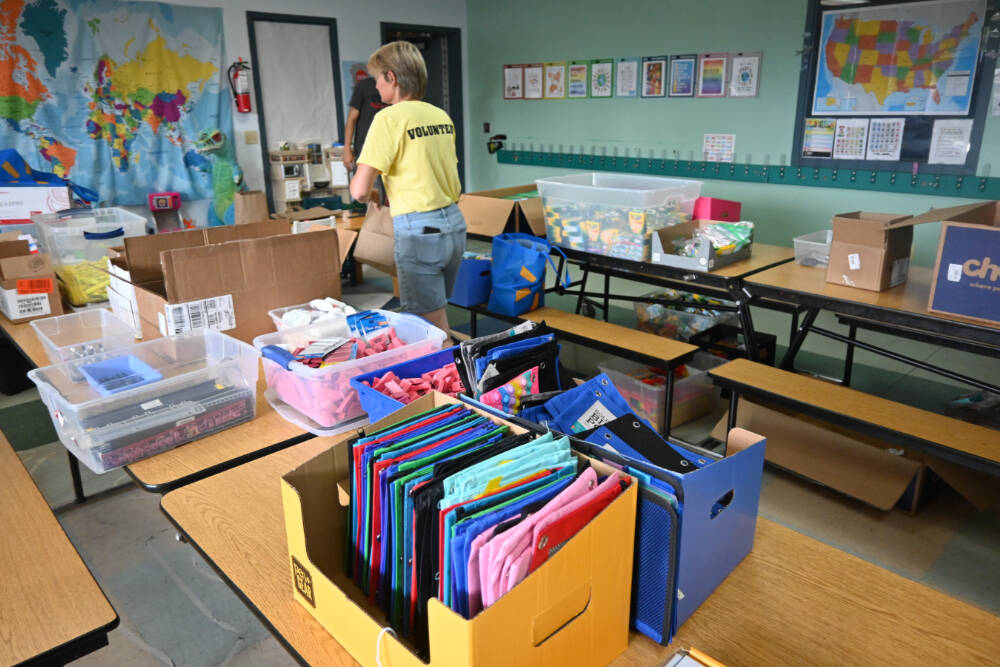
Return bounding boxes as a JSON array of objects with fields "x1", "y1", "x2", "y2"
[{"x1": 382, "y1": 23, "x2": 465, "y2": 190}]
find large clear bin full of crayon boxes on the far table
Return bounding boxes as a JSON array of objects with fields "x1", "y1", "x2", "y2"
[{"x1": 536, "y1": 172, "x2": 702, "y2": 261}]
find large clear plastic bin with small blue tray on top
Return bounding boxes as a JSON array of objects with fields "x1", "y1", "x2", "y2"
[{"x1": 28, "y1": 329, "x2": 260, "y2": 473}]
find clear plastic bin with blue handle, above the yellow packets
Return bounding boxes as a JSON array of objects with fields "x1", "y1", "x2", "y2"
[{"x1": 32, "y1": 208, "x2": 148, "y2": 264}]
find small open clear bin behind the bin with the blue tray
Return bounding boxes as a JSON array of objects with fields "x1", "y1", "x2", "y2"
[{"x1": 30, "y1": 308, "x2": 135, "y2": 364}]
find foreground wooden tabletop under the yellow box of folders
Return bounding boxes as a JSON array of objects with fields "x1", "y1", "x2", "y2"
[{"x1": 160, "y1": 438, "x2": 1000, "y2": 667}]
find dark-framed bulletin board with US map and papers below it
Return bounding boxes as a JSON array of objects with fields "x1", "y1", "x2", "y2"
[{"x1": 792, "y1": 0, "x2": 1000, "y2": 175}]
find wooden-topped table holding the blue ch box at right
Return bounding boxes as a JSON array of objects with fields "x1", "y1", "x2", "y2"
[{"x1": 746, "y1": 263, "x2": 1000, "y2": 392}]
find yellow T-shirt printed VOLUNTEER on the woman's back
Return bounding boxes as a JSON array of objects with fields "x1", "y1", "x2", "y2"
[{"x1": 358, "y1": 101, "x2": 462, "y2": 216}]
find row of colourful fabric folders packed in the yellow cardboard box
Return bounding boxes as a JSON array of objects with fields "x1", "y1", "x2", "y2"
[{"x1": 348, "y1": 404, "x2": 630, "y2": 657}]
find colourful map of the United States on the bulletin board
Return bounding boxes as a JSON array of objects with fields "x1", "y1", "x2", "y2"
[{"x1": 813, "y1": 0, "x2": 985, "y2": 115}]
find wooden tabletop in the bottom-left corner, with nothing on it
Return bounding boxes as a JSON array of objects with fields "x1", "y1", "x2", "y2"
[{"x1": 0, "y1": 434, "x2": 118, "y2": 665}]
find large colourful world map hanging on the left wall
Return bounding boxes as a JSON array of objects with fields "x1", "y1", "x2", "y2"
[{"x1": 0, "y1": 0, "x2": 232, "y2": 205}]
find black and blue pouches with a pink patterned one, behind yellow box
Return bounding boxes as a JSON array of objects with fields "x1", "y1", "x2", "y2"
[{"x1": 455, "y1": 321, "x2": 572, "y2": 415}]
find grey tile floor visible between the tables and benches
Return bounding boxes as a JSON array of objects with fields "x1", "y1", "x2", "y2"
[{"x1": 7, "y1": 264, "x2": 1000, "y2": 666}]
